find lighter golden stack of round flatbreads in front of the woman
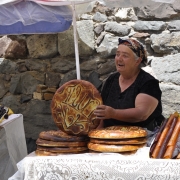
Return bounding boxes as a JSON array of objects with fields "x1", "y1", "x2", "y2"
[{"x1": 88, "y1": 126, "x2": 147, "y2": 154}]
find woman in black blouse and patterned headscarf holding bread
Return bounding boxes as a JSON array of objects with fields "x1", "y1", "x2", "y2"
[{"x1": 94, "y1": 38, "x2": 164, "y2": 131}]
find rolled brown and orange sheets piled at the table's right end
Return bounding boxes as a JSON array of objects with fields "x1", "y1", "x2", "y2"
[{"x1": 150, "y1": 112, "x2": 180, "y2": 159}]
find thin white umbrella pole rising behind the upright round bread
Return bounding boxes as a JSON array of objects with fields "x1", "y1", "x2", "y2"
[{"x1": 73, "y1": 3, "x2": 81, "y2": 79}]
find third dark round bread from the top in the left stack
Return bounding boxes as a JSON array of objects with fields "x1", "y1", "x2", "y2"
[{"x1": 37, "y1": 145, "x2": 88, "y2": 153}]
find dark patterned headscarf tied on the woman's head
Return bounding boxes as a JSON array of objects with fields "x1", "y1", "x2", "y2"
[{"x1": 118, "y1": 38, "x2": 147, "y2": 63}]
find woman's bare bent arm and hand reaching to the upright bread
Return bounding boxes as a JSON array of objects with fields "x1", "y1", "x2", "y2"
[{"x1": 94, "y1": 93, "x2": 158, "y2": 122}]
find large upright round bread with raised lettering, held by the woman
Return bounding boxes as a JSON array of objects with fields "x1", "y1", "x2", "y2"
[{"x1": 51, "y1": 80, "x2": 102, "y2": 135}]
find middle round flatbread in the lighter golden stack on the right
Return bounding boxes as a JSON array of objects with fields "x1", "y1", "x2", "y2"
[{"x1": 90, "y1": 137, "x2": 147, "y2": 145}]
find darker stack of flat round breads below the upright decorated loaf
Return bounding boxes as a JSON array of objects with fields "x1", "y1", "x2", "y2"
[{"x1": 35, "y1": 130, "x2": 88, "y2": 156}]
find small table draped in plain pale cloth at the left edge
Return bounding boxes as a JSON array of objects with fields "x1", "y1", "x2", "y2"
[{"x1": 0, "y1": 114, "x2": 27, "y2": 180}]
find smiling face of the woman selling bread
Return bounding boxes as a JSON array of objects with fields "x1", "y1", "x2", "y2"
[{"x1": 115, "y1": 44, "x2": 140, "y2": 73}]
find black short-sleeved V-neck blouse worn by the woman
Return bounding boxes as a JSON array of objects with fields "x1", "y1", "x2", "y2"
[{"x1": 101, "y1": 69, "x2": 164, "y2": 131}]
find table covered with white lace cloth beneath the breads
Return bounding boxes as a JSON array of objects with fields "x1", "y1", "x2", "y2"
[{"x1": 9, "y1": 147, "x2": 180, "y2": 180}]
